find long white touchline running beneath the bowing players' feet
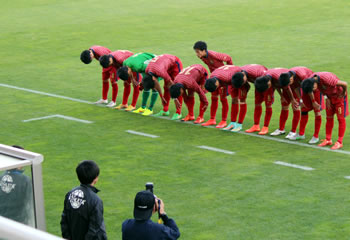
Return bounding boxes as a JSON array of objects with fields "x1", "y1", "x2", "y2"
[{"x1": 0, "y1": 83, "x2": 350, "y2": 155}]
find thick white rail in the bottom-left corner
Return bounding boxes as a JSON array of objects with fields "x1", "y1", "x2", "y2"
[{"x1": 0, "y1": 216, "x2": 62, "y2": 240}]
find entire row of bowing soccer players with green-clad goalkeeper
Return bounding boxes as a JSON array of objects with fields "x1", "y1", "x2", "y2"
[{"x1": 80, "y1": 41, "x2": 348, "y2": 149}]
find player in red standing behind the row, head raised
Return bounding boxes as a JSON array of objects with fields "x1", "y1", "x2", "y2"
[{"x1": 193, "y1": 41, "x2": 233, "y2": 73}]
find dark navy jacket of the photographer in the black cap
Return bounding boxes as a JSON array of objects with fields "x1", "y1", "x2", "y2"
[{"x1": 122, "y1": 215, "x2": 180, "y2": 240}]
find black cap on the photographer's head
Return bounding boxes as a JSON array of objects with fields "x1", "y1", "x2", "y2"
[{"x1": 134, "y1": 191, "x2": 155, "y2": 220}]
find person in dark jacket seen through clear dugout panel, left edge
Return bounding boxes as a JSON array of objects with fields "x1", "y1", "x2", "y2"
[{"x1": 0, "y1": 145, "x2": 34, "y2": 226}]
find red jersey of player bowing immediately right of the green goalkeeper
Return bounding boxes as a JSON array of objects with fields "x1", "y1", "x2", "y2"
[{"x1": 145, "y1": 54, "x2": 179, "y2": 82}]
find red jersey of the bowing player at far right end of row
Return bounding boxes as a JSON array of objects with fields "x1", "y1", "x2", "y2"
[{"x1": 309, "y1": 72, "x2": 343, "y2": 97}]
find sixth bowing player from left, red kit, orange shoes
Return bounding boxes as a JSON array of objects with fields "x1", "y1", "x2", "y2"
[{"x1": 202, "y1": 65, "x2": 241, "y2": 128}]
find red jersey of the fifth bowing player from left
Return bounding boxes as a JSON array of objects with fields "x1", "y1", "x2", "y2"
[{"x1": 174, "y1": 64, "x2": 208, "y2": 104}]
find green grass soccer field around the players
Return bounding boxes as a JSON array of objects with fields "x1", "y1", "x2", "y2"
[{"x1": 0, "y1": 0, "x2": 350, "y2": 240}]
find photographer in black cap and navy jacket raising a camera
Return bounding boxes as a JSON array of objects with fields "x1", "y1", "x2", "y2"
[{"x1": 122, "y1": 191, "x2": 180, "y2": 240}]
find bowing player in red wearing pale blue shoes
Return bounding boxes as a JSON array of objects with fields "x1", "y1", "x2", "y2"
[{"x1": 224, "y1": 64, "x2": 267, "y2": 132}]
